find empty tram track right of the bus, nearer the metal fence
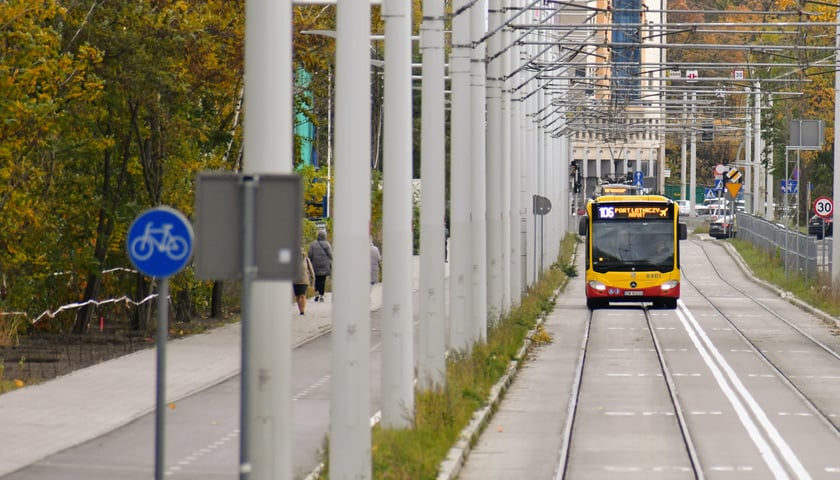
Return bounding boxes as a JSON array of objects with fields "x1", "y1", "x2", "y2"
[{"x1": 683, "y1": 241, "x2": 840, "y2": 437}]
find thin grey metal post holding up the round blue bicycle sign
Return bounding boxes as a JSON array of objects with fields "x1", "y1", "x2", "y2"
[{"x1": 155, "y1": 277, "x2": 169, "y2": 480}]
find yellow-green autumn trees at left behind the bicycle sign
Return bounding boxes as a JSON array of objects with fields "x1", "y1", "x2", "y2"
[{"x1": 0, "y1": 0, "x2": 421, "y2": 333}]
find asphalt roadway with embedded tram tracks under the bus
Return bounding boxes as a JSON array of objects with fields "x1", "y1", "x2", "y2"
[{"x1": 457, "y1": 237, "x2": 840, "y2": 480}]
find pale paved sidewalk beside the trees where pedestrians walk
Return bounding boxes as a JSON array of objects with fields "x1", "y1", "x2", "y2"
[{"x1": 0, "y1": 268, "x2": 394, "y2": 476}]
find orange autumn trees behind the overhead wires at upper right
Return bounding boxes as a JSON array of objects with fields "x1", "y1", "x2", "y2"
[{"x1": 668, "y1": 0, "x2": 837, "y2": 220}]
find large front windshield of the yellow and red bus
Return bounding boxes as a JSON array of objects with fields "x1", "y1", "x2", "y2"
[{"x1": 592, "y1": 219, "x2": 675, "y2": 273}]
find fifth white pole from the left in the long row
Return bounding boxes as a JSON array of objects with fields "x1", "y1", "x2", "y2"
[{"x1": 449, "y1": 0, "x2": 472, "y2": 351}]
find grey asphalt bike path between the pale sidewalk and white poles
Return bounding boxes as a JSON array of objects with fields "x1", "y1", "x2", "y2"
[{"x1": 3, "y1": 311, "x2": 388, "y2": 480}]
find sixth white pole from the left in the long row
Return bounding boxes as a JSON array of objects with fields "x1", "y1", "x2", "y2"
[{"x1": 470, "y1": 0, "x2": 487, "y2": 343}]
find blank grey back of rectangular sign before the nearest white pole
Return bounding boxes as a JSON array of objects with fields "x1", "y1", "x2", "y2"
[{"x1": 195, "y1": 172, "x2": 303, "y2": 280}]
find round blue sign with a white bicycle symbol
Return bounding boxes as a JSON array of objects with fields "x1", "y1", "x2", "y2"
[{"x1": 126, "y1": 207, "x2": 193, "y2": 277}]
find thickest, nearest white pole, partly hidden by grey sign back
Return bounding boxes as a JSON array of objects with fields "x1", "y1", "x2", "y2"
[{"x1": 240, "y1": 0, "x2": 293, "y2": 480}]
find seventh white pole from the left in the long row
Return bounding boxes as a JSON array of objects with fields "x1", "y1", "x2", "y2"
[{"x1": 484, "y1": 0, "x2": 504, "y2": 321}]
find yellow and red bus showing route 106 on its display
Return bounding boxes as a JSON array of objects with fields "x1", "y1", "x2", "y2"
[{"x1": 579, "y1": 195, "x2": 688, "y2": 309}]
